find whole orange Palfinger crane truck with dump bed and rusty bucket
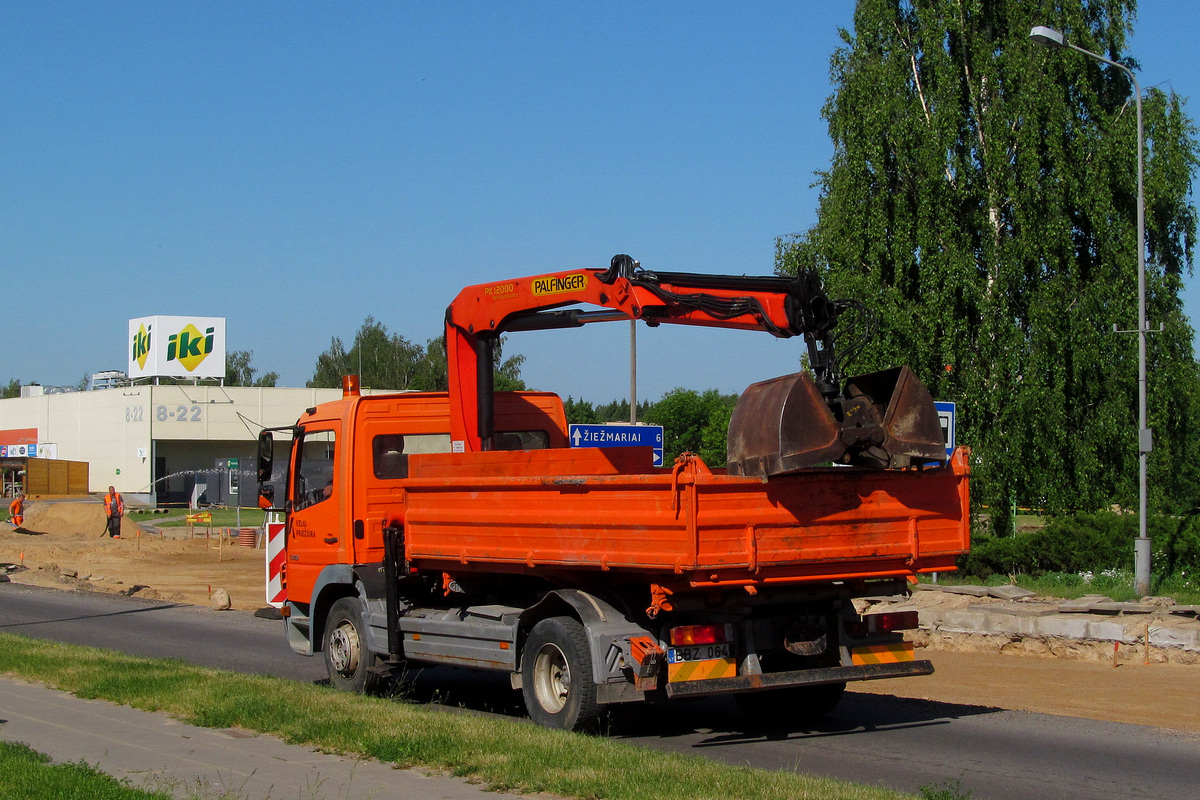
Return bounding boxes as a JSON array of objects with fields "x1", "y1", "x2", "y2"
[{"x1": 259, "y1": 257, "x2": 968, "y2": 728}]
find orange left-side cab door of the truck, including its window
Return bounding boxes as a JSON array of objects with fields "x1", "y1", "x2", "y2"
[{"x1": 280, "y1": 429, "x2": 346, "y2": 602}]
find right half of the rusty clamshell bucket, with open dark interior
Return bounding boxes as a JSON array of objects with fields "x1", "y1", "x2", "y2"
[{"x1": 841, "y1": 367, "x2": 946, "y2": 468}]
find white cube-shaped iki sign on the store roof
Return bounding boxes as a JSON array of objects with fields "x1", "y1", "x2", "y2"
[{"x1": 125, "y1": 317, "x2": 226, "y2": 378}]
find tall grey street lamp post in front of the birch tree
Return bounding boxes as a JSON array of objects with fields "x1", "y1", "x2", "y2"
[{"x1": 1030, "y1": 25, "x2": 1153, "y2": 596}]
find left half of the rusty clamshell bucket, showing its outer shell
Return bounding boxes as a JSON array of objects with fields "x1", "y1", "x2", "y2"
[{"x1": 726, "y1": 372, "x2": 846, "y2": 477}]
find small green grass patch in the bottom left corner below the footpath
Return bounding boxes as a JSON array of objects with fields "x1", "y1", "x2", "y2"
[{"x1": 0, "y1": 741, "x2": 170, "y2": 800}]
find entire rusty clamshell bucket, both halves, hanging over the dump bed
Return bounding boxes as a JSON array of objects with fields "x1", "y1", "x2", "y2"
[{"x1": 726, "y1": 367, "x2": 946, "y2": 477}]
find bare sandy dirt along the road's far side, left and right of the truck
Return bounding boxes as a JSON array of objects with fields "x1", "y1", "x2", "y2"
[{"x1": 0, "y1": 500, "x2": 1200, "y2": 732}]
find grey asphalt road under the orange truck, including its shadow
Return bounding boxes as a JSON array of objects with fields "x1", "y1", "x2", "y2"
[{"x1": 0, "y1": 584, "x2": 1200, "y2": 800}]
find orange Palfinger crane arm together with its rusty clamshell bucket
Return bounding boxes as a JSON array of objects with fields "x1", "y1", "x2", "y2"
[{"x1": 446, "y1": 254, "x2": 944, "y2": 474}]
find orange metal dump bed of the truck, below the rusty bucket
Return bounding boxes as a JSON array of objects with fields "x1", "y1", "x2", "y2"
[{"x1": 404, "y1": 449, "x2": 970, "y2": 587}]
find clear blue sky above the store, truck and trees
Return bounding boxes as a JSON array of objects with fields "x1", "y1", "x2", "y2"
[{"x1": 0, "y1": 0, "x2": 1200, "y2": 402}]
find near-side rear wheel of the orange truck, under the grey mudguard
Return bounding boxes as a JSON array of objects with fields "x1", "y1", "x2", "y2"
[{"x1": 521, "y1": 616, "x2": 600, "y2": 730}]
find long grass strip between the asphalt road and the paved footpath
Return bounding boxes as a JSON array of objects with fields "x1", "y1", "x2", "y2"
[{"x1": 0, "y1": 633, "x2": 911, "y2": 800}]
